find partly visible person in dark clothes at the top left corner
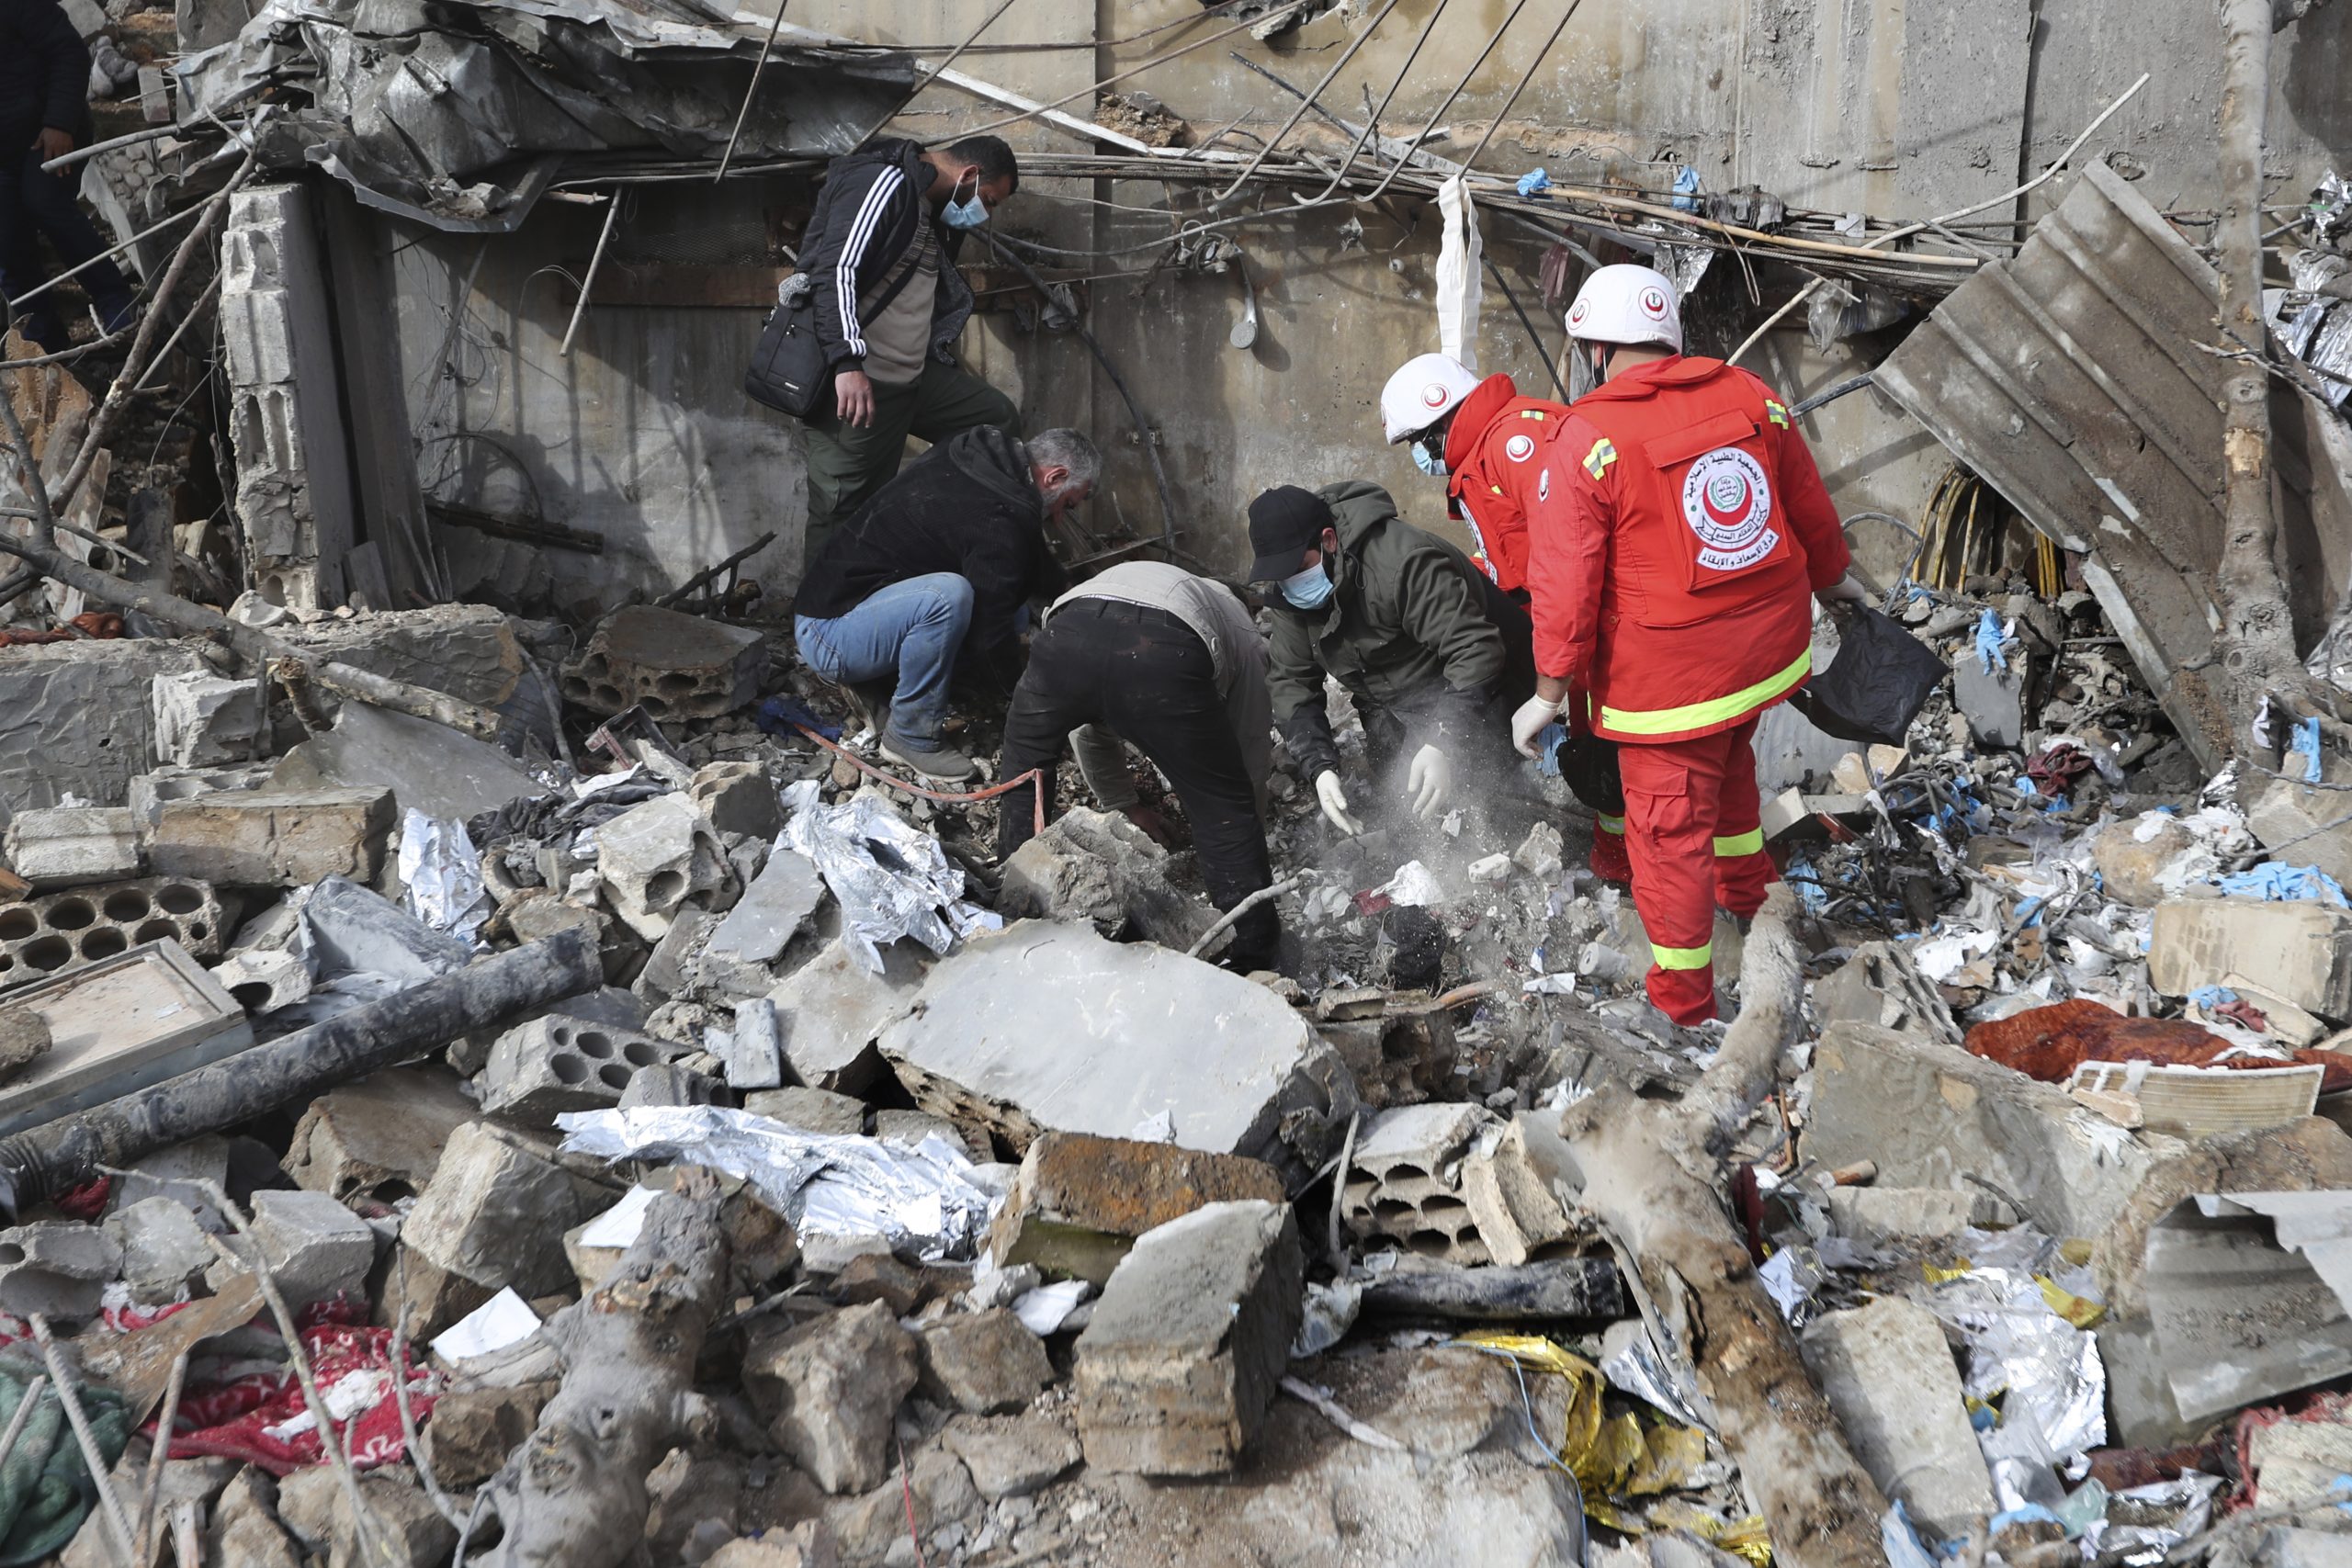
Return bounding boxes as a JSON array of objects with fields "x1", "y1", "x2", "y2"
[{"x1": 0, "y1": 0, "x2": 134, "y2": 353}]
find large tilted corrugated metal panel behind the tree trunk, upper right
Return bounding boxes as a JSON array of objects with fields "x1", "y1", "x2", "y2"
[{"x1": 1877, "y1": 164, "x2": 2352, "y2": 766}]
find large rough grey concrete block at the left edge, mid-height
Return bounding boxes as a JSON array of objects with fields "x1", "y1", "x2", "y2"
[{"x1": 0, "y1": 637, "x2": 207, "y2": 823}]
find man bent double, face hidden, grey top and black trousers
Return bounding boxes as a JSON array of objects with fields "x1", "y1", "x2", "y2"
[{"x1": 997, "y1": 562, "x2": 1280, "y2": 974}]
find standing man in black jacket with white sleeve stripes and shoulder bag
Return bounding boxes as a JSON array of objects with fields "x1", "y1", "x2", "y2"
[{"x1": 799, "y1": 136, "x2": 1021, "y2": 562}]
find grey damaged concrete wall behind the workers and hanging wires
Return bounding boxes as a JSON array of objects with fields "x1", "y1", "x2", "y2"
[{"x1": 380, "y1": 0, "x2": 2352, "y2": 602}]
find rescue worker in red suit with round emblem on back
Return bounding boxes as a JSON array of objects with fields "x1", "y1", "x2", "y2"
[{"x1": 1510, "y1": 265, "x2": 1863, "y2": 1025}]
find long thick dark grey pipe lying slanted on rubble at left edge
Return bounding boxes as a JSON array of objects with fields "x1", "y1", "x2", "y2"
[{"x1": 0, "y1": 931, "x2": 605, "y2": 1223}]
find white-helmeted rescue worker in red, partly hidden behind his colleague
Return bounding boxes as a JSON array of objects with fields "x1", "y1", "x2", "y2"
[{"x1": 1381, "y1": 355, "x2": 1633, "y2": 882}]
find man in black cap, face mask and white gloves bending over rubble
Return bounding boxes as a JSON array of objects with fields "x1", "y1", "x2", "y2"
[{"x1": 1249, "y1": 479, "x2": 1536, "y2": 832}]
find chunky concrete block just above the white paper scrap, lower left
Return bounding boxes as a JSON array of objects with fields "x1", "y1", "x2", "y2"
[{"x1": 400, "y1": 1122, "x2": 588, "y2": 1298}]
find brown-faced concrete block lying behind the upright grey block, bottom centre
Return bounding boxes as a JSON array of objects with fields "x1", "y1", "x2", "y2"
[{"x1": 988, "y1": 1134, "x2": 1284, "y2": 1283}]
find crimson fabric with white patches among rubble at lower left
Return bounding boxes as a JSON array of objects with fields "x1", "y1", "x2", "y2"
[{"x1": 172, "y1": 1303, "x2": 437, "y2": 1476}]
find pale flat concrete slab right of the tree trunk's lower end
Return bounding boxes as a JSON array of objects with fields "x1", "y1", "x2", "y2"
[{"x1": 1802, "y1": 1295, "x2": 1996, "y2": 1540}]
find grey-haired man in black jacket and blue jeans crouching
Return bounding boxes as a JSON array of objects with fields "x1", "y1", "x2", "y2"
[{"x1": 793, "y1": 425, "x2": 1103, "y2": 781}]
